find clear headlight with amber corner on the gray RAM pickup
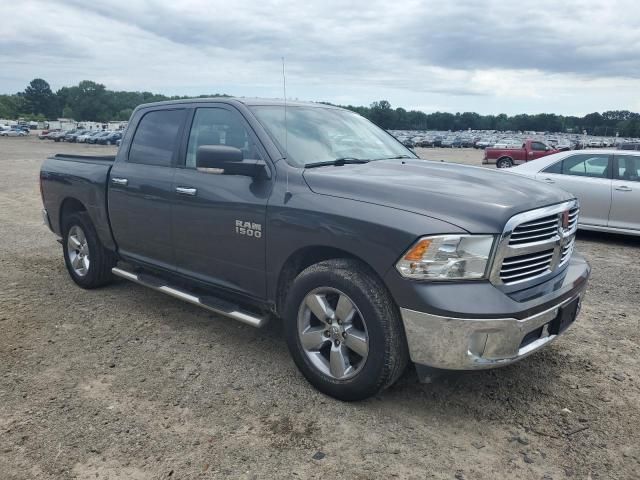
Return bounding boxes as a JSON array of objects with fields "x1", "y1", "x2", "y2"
[{"x1": 396, "y1": 235, "x2": 494, "y2": 280}]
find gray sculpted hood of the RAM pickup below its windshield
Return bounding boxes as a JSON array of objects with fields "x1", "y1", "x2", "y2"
[{"x1": 304, "y1": 159, "x2": 574, "y2": 233}]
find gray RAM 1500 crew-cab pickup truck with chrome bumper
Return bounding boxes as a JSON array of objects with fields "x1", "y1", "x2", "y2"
[{"x1": 40, "y1": 99, "x2": 590, "y2": 400}]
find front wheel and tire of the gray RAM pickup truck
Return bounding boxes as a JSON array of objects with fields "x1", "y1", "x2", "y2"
[{"x1": 284, "y1": 259, "x2": 408, "y2": 401}]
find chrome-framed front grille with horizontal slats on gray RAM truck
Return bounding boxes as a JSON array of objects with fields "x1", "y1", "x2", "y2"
[{"x1": 491, "y1": 200, "x2": 580, "y2": 288}]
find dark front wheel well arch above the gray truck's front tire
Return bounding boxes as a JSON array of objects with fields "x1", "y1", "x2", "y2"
[{"x1": 276, "y1": 246, "x2": 379, "y2": 315}]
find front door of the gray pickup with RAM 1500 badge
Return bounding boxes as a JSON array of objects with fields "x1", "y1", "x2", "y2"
[{"x1": 172, "y1": 105, "x2": 271, "y2": 298}]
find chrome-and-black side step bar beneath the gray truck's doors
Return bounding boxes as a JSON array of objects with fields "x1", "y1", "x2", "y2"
[{"x1": 111, "y1": 267, "x2": 269, "y2": 328}]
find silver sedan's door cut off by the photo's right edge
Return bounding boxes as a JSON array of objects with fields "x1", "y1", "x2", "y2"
[{"x1": 609, "y1": 155, "x2": 640, "y2": 230}]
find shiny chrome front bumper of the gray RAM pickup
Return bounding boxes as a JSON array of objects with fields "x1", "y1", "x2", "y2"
[{"x1": 400, "y1": 259, "x2": 590, "y2": 370}]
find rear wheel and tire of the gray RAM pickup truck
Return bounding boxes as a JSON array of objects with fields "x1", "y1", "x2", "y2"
[{"x1": 62, "y1": 212, "x2": 116, "y2": 289}]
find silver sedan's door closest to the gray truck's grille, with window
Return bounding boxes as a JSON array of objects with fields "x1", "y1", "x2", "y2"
[{"x1": 536, "y1": 153, "x2": 611, "y2": 227}]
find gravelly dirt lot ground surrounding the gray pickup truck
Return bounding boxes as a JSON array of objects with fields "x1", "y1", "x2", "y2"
[{"x1": 0, "y1": 137, "x2": 640, "y2": 480}]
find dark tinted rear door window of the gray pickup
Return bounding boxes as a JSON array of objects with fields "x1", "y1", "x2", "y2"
[{"x1": 129, "y1": 110, "x2": 185, "y2": 167}]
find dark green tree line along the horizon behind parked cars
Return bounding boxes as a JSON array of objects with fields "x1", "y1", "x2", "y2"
[{"x1": 0, "y1": 78, "x2": 640, "y2": 137}]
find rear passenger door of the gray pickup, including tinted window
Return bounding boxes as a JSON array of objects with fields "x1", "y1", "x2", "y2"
[{"x1": 108, "y1": 108, "x2": 187, "y2": 269}]
